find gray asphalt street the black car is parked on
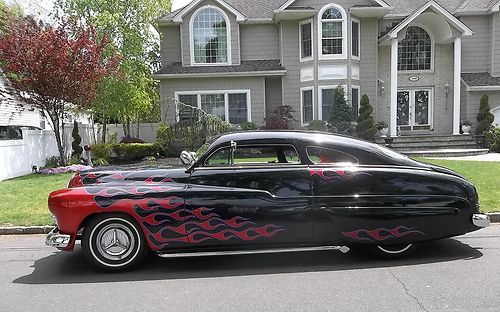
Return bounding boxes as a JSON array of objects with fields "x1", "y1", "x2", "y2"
[{"x1": 0, "y1": 224, "x2": 500, "y2": 312}]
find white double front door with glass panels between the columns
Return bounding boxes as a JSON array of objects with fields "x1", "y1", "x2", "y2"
[{"x1": 397, "y1": 89, "x2": 432, "y2": 130}]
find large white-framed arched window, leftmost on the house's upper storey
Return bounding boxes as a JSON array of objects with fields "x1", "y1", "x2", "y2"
[{"x1": 191, "y1": 7, "x2": 229, "y2": 64}]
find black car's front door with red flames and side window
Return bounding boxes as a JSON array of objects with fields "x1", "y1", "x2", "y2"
[{"x1": 185, "y1": 144, "x2": 313, "y2": 248}]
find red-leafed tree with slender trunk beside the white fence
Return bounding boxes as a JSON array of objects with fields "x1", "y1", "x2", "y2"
[{"x1": 0, "y1": 17, "x2": 118, "y2": 165}]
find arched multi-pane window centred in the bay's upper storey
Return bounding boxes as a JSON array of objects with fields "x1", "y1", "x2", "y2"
[{"x1": 319, "y1": 5, "x2": 347, "y2": 56}]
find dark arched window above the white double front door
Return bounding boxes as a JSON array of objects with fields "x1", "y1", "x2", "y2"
[{"x1": 398, "y1": 26, "x2": 432, "y2": 70}]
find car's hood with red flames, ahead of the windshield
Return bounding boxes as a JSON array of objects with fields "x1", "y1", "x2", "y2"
[{"x1": 68, "y1": 168, "x2": 189, "y2": 188}]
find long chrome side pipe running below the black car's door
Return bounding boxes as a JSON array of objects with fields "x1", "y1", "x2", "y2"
[{"x1": 158, "y1": 246, "x2": 350, "y2": 258}]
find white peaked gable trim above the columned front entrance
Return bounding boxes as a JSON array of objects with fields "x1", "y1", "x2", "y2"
[{"x1": 381, "y1": 0, "x2": 473, "y2": 40}]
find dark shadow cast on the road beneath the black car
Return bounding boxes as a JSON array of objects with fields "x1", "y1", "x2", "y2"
[{"x1": 13, "y1": 239, "x2": 483, "y2": 284}]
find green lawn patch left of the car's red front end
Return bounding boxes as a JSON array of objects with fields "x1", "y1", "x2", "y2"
[{"x1": 0, "y1": 173, "x2": 72, "y2": 226}]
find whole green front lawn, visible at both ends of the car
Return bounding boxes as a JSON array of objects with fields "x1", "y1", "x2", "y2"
[{"x1": 0, "y1": 158, "x2": 500, "y2": 226}]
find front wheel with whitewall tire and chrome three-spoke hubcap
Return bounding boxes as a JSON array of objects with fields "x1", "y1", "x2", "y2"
[{"x1": 82, "y1": 214, "x2": 147, "y2": 270}]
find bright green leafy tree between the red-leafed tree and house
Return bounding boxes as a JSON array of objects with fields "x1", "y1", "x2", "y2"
[{"x1": 55, "y1": 0, "x2": 171, "y2": 139}]
